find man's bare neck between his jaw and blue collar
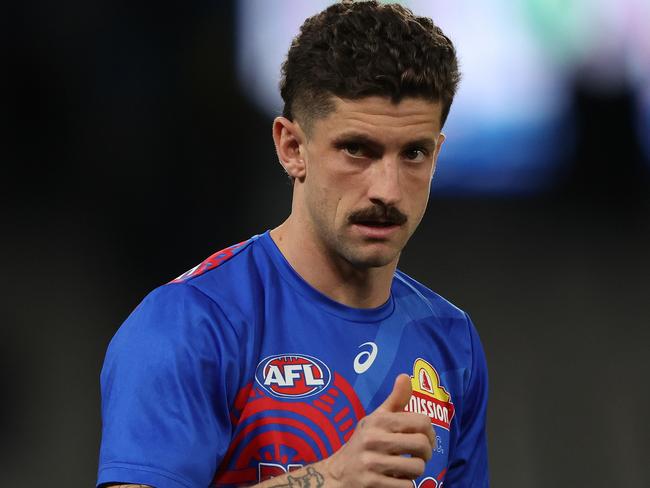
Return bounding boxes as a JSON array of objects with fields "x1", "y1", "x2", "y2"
[{"x1": 271, "y1": 216, "x2": 397, "y2": 308}]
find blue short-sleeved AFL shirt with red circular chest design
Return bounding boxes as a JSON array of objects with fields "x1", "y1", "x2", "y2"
[{"x1": 97, "y1": 232, "x2": 488, "y2": 488}]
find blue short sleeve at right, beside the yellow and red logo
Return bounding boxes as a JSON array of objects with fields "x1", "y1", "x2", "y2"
[{"x1": 444, "y1": 317, "x2": 490, "y2": 488}]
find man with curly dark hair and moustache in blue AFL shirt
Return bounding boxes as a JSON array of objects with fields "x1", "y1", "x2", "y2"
[{"x1": 98, "y1": 2, "x2": 488, "y2": 488}]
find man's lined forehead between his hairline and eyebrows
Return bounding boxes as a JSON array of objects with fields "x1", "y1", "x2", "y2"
[{"x1": 313, "y1": 96, "x2": 442, "y2": 139}]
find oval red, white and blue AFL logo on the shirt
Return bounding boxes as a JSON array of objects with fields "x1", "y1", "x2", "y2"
[{"x1": 255, "y1": 354, "x2": 331, "y2": 398}]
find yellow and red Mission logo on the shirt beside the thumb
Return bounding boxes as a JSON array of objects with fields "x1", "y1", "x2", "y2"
[{"x1": 404, "y1": 358, "x2": 454, "y2": 430}]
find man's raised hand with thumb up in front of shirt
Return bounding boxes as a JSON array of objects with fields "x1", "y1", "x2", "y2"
[{"x1": 319, "y1": 374, "x2": 436, "y2": 488}]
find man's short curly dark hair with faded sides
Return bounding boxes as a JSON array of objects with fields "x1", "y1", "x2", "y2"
[{"x1": 280, "y1": 0, "x2": 460, "y2": 128}]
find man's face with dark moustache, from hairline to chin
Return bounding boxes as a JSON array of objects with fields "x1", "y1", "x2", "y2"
[{"x1": 296, "y1": 97, "x2": 444, "y2": 268}]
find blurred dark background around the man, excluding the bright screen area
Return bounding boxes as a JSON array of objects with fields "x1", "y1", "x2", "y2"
[{"x1": 0, "y1": 0, "x2": 650, "y2": 488}]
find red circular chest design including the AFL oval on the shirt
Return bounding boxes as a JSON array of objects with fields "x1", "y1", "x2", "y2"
[{"x1": 212, "y1": 368, "x2": 362, "y2": 488}]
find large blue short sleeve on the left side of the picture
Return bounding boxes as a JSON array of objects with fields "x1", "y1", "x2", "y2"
[{"x1": 97, "y1": 283, "x2": 239, "y2": 488}]
